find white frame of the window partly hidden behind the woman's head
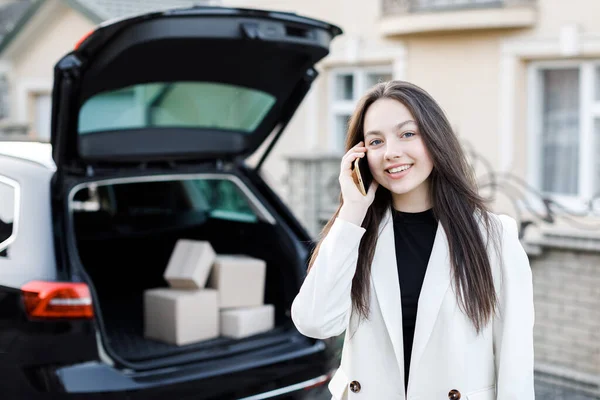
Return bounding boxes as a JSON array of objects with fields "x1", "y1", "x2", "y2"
[{"x1": 327, "y1": 64, "x2": 394, "y2": 153}]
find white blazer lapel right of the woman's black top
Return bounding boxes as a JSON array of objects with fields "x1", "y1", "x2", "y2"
[{"x1": 409, "y1": 223, "x2": 450, "y2": 390}]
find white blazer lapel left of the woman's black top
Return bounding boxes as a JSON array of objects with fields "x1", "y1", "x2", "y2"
[{"x1": 371, "y1": 210, "x2": 405, "y2": 387}]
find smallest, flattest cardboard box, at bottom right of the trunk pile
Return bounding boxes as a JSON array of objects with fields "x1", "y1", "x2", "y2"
[{"x1": 220, "y1": 304, "x2": 275, "y2": 339}]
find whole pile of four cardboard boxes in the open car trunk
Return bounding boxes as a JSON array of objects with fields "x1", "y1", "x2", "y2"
[{"x1": 144, "y1": 239, "x2": 275, "y2": 345}]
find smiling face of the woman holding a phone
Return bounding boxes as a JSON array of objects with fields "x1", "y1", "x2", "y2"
[{"x1": 363, "y1": 99, "x2": 433, "y2": 211}]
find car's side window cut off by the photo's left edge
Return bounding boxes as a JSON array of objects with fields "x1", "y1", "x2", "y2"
[{"x1": 0, "y1": 176, "x2": 19, "y2": 257}]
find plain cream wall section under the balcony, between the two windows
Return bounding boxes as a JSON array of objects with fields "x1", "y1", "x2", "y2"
[{"x1": 406, "y1": 32, "x2": 501, "y2": 165}]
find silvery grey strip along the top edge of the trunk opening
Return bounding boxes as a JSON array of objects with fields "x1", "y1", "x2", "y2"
[{"x1": 69, "y1": 173, "x2": 276, "y2": 225}]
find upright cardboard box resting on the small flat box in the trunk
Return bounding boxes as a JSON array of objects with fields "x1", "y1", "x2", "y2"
[{"x1": 208, "y1": 255, "x2": 267, "y2": 308}]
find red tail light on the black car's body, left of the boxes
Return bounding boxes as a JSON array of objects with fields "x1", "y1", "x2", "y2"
[{"x1": 21, "y1": 281, "x2": 94, "y2": 319}]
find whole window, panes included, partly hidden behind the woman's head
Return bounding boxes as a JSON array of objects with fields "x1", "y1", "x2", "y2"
[{"x1": 330, "y1": 66, "x2": 392, "y2": 151}]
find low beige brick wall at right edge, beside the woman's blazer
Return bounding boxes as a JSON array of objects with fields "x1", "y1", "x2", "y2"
[{"x1": 531, "y1": 249, "x2": 600, "y2": 390}]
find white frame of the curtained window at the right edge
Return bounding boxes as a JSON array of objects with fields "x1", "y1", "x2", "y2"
[{"x1": 527, "y1": 59, "x2": 600, "y2": 212}]
